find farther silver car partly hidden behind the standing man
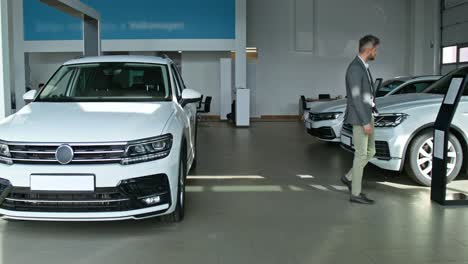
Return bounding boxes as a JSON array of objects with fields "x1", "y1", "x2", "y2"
[{"x1": 304, "y1": 76, "x2": 441, "y2": 142}]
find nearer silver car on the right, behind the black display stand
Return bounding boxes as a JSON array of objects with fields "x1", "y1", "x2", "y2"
[{"x1": 341, "y1": 67, "x2": 468, "y2": 186}]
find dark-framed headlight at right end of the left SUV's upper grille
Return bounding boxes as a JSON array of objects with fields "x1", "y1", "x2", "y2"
[{"x1": 121, "y1": 134, "x2": 172, "y2": 165}]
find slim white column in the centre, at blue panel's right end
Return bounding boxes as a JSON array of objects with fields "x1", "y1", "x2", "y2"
[{"x1": 235, "y1": 0, "x2": 250, "y2": 127}]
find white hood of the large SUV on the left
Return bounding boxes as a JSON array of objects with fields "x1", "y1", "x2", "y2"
[{"x1": 0, "y1": 102, "x2": 175, "y2": 143}]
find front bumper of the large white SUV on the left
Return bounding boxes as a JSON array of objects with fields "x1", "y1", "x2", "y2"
[{"x1": 0, "y1": 154, "x2": 179, "y2": 221}]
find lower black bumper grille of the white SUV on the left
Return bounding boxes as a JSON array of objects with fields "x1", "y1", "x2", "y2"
[{"x1": 0, "y1": 174, "x2": 171, "y2": 213}]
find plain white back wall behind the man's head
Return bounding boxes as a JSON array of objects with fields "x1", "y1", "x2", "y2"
[{"x1": 247, "y1": 0, "x2": 432, "y2": 115}]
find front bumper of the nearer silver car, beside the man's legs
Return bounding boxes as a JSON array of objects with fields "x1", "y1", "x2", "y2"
[{"x1": 340, "y1": 126, "x2": 408, "y2": 171}]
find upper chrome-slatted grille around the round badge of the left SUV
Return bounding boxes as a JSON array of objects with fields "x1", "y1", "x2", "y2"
[{"x1": 8, "y1": 143, "x2": 126, "y2": 164}]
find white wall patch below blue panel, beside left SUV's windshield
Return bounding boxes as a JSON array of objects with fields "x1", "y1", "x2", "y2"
[{"x1": 26, "y1": 52, "x2": 81, "y2": 88}]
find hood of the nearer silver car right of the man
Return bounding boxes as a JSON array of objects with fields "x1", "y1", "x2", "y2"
[{"x1": 376, "y1": 93, "x2": 444, "y2": 113}]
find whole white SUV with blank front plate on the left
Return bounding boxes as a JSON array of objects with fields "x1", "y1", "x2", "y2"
[{"x1": 0, "y1": 56, "x2": 201, "y2": 222}]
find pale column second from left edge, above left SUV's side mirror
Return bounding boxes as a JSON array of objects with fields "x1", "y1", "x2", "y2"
[{"x1": 10, "y1": 0, "x2": 26, "y2": 111}]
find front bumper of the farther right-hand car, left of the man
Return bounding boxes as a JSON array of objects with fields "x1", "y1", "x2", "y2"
[{"x1": 305, "y1": 119, "x2": 342, "y2": 142}]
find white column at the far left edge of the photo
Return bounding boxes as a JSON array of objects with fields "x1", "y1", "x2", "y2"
[{"x1": 0, "y1": 0, "x2": 11, "y2": 119}]
